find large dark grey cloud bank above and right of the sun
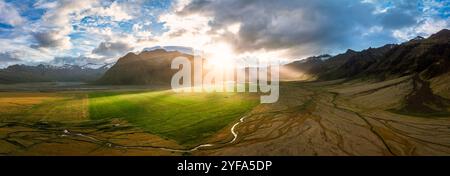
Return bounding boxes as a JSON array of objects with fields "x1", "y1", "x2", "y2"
[{"x1": 178, "y1": 0, "x2": 426, "y2": 54}]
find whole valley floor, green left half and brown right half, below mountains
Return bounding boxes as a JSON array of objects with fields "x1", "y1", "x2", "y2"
[{"x1": 0, "y1": 74, "x2": 450, "y2": 156}]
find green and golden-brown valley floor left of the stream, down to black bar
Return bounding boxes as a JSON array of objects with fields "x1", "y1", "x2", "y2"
[{"x1": 0, "y1": 89, "x2": 259, "y2": 155}]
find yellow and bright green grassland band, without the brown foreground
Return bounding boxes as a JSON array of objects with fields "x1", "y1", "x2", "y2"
[{"x1": 0, "y1": 91, "x2": 259, "y2": 147}]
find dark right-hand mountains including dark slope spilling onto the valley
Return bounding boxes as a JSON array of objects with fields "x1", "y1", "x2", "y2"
[{"x1": 282, "y1": 29, "x2": 450, "y2": 115}]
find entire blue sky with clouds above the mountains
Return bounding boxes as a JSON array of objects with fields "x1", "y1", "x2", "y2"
[{"x1": 0, "y1": 0, "x2": 450, "y2": 67}]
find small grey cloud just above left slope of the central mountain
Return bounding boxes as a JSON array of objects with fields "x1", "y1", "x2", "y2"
[{"x1": 92, "y1": 42, "x2": 133, "y2": 56}]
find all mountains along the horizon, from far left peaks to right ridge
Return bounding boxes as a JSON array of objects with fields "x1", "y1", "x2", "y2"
[{"x1": 0, "y1": 29, "x2": 450, "y2": 88}]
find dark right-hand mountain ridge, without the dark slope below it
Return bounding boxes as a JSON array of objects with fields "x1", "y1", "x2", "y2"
[{"x1": 285, "y1": 29, "x2": 450, "y2": 80}]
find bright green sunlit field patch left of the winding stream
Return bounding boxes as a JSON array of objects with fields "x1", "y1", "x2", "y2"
[{"x1": 89, "y1": 91, "x2": 259, "y2": 146}]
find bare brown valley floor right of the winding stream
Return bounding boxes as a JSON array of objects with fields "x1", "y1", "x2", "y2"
[{"x1": 196, "y1": 74, "x2": 450, "y2": 156}]
